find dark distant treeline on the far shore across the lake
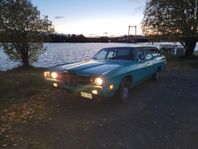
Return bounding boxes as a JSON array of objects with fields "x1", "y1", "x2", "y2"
[{"x1": 0, "y1": 32, "x2": 198, "y2": 43}]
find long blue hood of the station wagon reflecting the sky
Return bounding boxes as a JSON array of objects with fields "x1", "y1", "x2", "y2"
[{"x1": 52, "y1": 60, "x2": 131, "y2": 76}]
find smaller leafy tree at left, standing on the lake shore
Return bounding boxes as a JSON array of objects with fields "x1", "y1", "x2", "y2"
[{"x1": 0, "y1": 0, "x2": 53, "y2": 66}]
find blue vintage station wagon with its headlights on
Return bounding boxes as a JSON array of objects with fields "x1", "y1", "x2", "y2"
[{"x1": 44, "y1": 46, "x2": 166, "y2": 103}]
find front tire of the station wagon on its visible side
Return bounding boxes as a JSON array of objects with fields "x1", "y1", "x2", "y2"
[{"x1": 119, "y1": 79, "x2": 130, "y2": 103}]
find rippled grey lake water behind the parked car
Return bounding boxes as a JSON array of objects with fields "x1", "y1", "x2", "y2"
[{"x1": 0, "y1": 43, "x2": 198, "y2": 71}]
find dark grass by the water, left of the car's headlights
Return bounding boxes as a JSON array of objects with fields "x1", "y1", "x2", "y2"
[{"x1": 0, "y1": 68, "x2": 46, "y2": 104}]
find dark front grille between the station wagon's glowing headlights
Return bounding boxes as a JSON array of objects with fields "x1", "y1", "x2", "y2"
[{"x1": 63, "y1": 73, "x2": 91, "y2": 86}]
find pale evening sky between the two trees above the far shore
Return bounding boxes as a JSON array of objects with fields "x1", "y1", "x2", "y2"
[{"x1": 31, "y1": 0, "x2": 146, "y2": 36}]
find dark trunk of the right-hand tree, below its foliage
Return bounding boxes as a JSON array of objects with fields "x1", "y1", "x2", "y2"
[{"x1": 184, "y1": 38, "x2": 197, "y2": 57}]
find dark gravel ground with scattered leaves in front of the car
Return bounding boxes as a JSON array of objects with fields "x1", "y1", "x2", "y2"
[{"x1": 3, "y1": 71, "x2": 198, "y2": 149}]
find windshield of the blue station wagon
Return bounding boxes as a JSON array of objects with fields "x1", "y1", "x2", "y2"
[{"x1": 93, "y1": 48, "x2": 134, "y2": 60}]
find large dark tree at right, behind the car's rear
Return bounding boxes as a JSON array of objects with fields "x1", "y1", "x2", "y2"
[{"x1": 143, "y1": 0, "x2": 198, "y2": 56}]
